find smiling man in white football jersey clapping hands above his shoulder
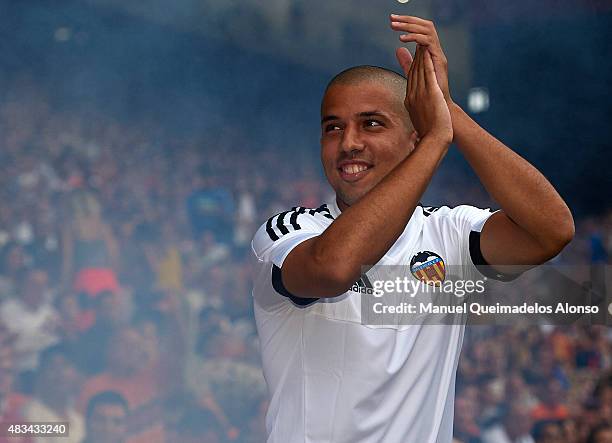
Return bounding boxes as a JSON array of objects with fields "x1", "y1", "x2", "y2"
[{"x1": 252, "y1": 15, "x2": 574, "y2": 443}]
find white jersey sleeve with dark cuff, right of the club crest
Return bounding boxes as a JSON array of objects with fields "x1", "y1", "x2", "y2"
[{"x1": 449, "y1": 205, "x2": 518, "y2": 281}]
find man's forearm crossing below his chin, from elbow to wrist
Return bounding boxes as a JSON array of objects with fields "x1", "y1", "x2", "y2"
[{"x1": 313, "y1": 136, "x2": 448, "y2": 284}]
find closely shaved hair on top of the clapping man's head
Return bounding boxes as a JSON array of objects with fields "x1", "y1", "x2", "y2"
[{"x1": 321, "y1": 65, "x2": 412, "y2": 128}]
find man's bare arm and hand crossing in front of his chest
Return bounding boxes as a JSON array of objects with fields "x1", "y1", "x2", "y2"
[{"x1": 282, "y1": 49, "x2": 452, "y2": 297}]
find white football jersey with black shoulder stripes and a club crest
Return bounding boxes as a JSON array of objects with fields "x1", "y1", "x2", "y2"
[{"x1": 252, "y1": 201, "x2": 500, "y2": 443}]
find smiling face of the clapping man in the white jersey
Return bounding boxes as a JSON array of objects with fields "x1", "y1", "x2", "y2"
[{"x1": 321, "y1": 82, "x2": 414, "y2": 209}]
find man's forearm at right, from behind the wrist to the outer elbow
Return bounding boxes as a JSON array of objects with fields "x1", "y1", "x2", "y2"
[{"x1": 449, "y1": 104, "x2": 574, "y2": 250}]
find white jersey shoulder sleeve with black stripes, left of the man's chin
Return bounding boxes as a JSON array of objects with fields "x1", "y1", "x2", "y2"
[{"x1": 251, "y1": 208, "x2": 326, "y2": 268}]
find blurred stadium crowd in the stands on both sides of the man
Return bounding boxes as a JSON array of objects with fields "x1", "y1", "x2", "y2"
[{"x1": 0, "y1": 84, "x2": 612, "y2": 443}]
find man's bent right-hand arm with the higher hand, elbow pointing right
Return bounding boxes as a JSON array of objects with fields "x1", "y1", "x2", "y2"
[{"x1": 391, "y1": 15, "x2": 574, "y2": 272}]
